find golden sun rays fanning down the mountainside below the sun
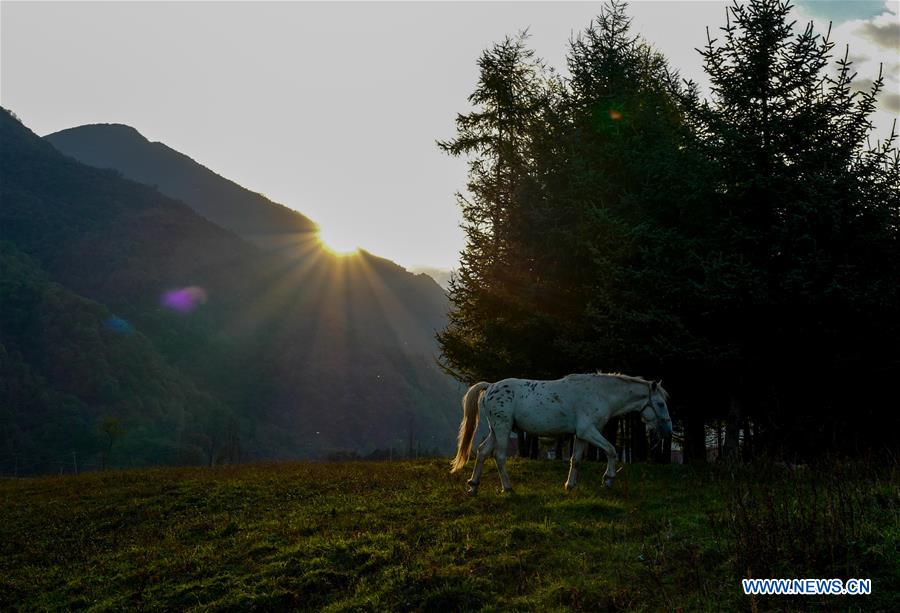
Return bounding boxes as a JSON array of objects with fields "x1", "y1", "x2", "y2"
[{"x1": 214, "y1": 233, "x2": 430, "y2": 402}]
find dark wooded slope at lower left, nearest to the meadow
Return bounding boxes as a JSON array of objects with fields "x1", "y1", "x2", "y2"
[{"x1": 0, "y1": 242, "x2": 216, "y2": 474}]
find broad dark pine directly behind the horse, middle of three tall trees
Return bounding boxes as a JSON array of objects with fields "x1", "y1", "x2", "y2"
[{"x1": 554, "y1": 2, "x2": 703, "y2": 375}]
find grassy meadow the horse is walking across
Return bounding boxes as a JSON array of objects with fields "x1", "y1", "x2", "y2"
[{"x1": 0, "y1": 460, "x2": 900, "y2": 611}]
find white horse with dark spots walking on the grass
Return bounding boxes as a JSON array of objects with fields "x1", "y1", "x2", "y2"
[{"x1": 451, "y1": 373, "x2": 672, "y2": 495}]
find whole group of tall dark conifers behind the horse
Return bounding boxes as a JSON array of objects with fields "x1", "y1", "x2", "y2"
[{"x1": 439, "y1": 0, "x2": 900, "y2": 459}]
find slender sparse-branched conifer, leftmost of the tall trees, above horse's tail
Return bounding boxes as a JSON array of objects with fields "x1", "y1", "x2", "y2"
[{"x1": 438, "y1": 33, "x2": 549, "y2": 381}]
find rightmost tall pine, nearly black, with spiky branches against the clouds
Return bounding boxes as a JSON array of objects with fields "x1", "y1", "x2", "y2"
[{"x1": 685, "y1": 0, "x2": 900, "y2": 451}]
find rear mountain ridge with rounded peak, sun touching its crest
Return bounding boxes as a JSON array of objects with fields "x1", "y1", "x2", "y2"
[{"x1": 44, "y1": 124, "x2": 449, "y2": 354}]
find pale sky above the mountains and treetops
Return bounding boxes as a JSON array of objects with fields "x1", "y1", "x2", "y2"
[{"x1": 0, "y1": 0, "x2": 900, "y2": 269}]
